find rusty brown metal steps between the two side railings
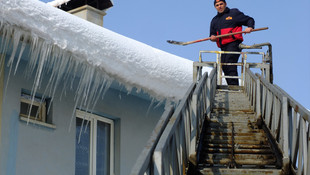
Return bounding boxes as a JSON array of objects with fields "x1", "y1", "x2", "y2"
[{"x1": 196, "y1": 89, "x2": 282, "y2": 175}]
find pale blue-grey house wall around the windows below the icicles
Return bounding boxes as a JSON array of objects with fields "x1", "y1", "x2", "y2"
[{"x1": 0, "y1": 53, "x2": 163, "y2": 175}]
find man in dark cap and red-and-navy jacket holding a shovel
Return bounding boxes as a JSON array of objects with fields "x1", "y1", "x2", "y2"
[{"x1": 210, "y1": 0, "x2": 255, "y2": 85}]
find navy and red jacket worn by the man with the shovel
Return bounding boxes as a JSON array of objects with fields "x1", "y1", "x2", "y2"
[{"x1": 210, "y1": 7, "x2": 255, "y2": 48}]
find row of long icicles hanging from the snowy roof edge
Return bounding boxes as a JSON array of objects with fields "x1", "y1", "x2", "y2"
[{"x1": 0, "y1": 18, "x2": 168, "y2": 134}]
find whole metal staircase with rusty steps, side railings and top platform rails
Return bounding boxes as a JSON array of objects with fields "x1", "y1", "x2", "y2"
[{"x1": 130, "y1": 43, "x2": 310, "y2": 175}]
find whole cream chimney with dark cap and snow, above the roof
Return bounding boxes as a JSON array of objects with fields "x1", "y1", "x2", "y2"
[{"x1": 50, "y1": 0, "x2": 113, "y2": 26}]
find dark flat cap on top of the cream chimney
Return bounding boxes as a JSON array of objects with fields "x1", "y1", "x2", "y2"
[{"x1": 58, "y1": 0, "x2": 113, "y2": 11}]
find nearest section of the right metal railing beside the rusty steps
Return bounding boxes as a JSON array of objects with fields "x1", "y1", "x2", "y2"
[{"x1": 264, "y1": 81, "x2": 310, "y2": 175}]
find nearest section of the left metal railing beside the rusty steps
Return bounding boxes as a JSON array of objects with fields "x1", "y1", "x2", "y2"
[{"x1": 153, "y1": 83, "x2": 196, "y2": 174}]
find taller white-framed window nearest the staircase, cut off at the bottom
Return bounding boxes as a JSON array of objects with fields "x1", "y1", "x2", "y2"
[{"x1": 75, "y1": 110, "x2": 114, "y2": 175}]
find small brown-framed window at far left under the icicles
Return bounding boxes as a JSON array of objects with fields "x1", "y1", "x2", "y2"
[{"x1": 19, "y1": 90, "x2": 56, "y2": 128}]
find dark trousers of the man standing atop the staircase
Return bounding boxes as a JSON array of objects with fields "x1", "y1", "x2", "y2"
[{"x1": 221, "y1": 41, "x2": 241, "y2": 86}]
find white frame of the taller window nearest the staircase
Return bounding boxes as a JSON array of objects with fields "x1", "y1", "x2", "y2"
[{"x1": 75, "y1": 109, "x2": 115, "y2": 175}]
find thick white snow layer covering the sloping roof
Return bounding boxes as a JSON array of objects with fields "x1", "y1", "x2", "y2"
[{"x1": 0, "y1": 0, "x2": 193, "y2": 101}]
